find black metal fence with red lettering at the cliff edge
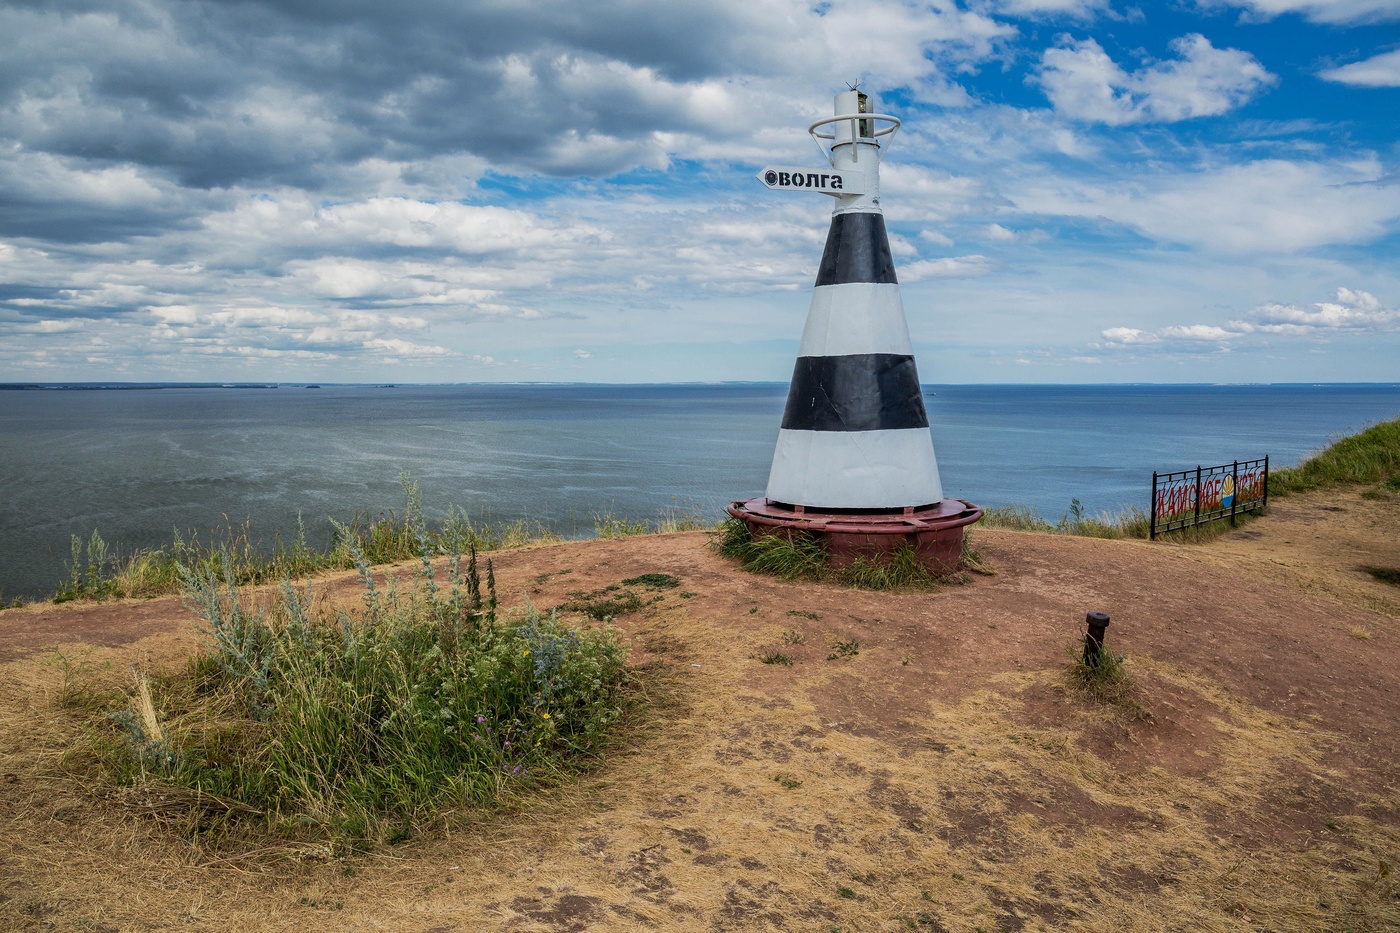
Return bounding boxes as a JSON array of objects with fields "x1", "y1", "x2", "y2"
[{"x1": 1149, "y1": 457, "x2": 1268, "y2": 539}]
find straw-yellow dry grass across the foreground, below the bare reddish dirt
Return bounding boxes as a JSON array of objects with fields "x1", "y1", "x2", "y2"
[{"x1": 0, "y1": 638, "x2": 1400, "y2": 930}]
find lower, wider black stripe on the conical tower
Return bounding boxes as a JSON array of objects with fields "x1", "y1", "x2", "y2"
[{"x1": 783, "y1": 353, "x2": 928, "y2": 431}]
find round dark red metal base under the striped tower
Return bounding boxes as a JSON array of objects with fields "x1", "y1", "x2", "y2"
[{"x1": 725, "y1": 497, "x2": 983, "y2": 573}]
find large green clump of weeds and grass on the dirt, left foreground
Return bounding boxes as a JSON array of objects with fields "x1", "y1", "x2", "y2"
[{"x1": 83, "y1": 537, "x2": 631, "y2": 846}]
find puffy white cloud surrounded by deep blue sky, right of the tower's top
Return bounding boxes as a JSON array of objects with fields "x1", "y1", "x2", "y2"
[{"x1": 1039, "y1": 34, "x2": 1278, "y2": 126}]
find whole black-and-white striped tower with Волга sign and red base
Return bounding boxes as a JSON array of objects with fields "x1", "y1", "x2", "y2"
[{"x1": 729, "y1": 90, "x2": 981, "y2": 569}]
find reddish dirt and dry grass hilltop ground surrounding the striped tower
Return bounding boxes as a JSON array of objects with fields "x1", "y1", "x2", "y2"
[{"x1": 0, "y1": 492, "x2": 1400, "y2": 933}]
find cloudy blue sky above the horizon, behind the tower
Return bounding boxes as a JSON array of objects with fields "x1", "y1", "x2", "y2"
[{"x1": 0, "y1": 0, "x2": 1400, "y2": 384}]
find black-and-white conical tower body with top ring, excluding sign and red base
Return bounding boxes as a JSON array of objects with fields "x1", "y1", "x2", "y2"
[{"x1": 767, "y1": 91, "x2": 944, "y2": 510}]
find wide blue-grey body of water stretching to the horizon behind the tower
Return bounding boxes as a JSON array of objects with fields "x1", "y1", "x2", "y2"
[{"x1": 0, "y1": 384, "x2": 1400, "y2": 598}]
